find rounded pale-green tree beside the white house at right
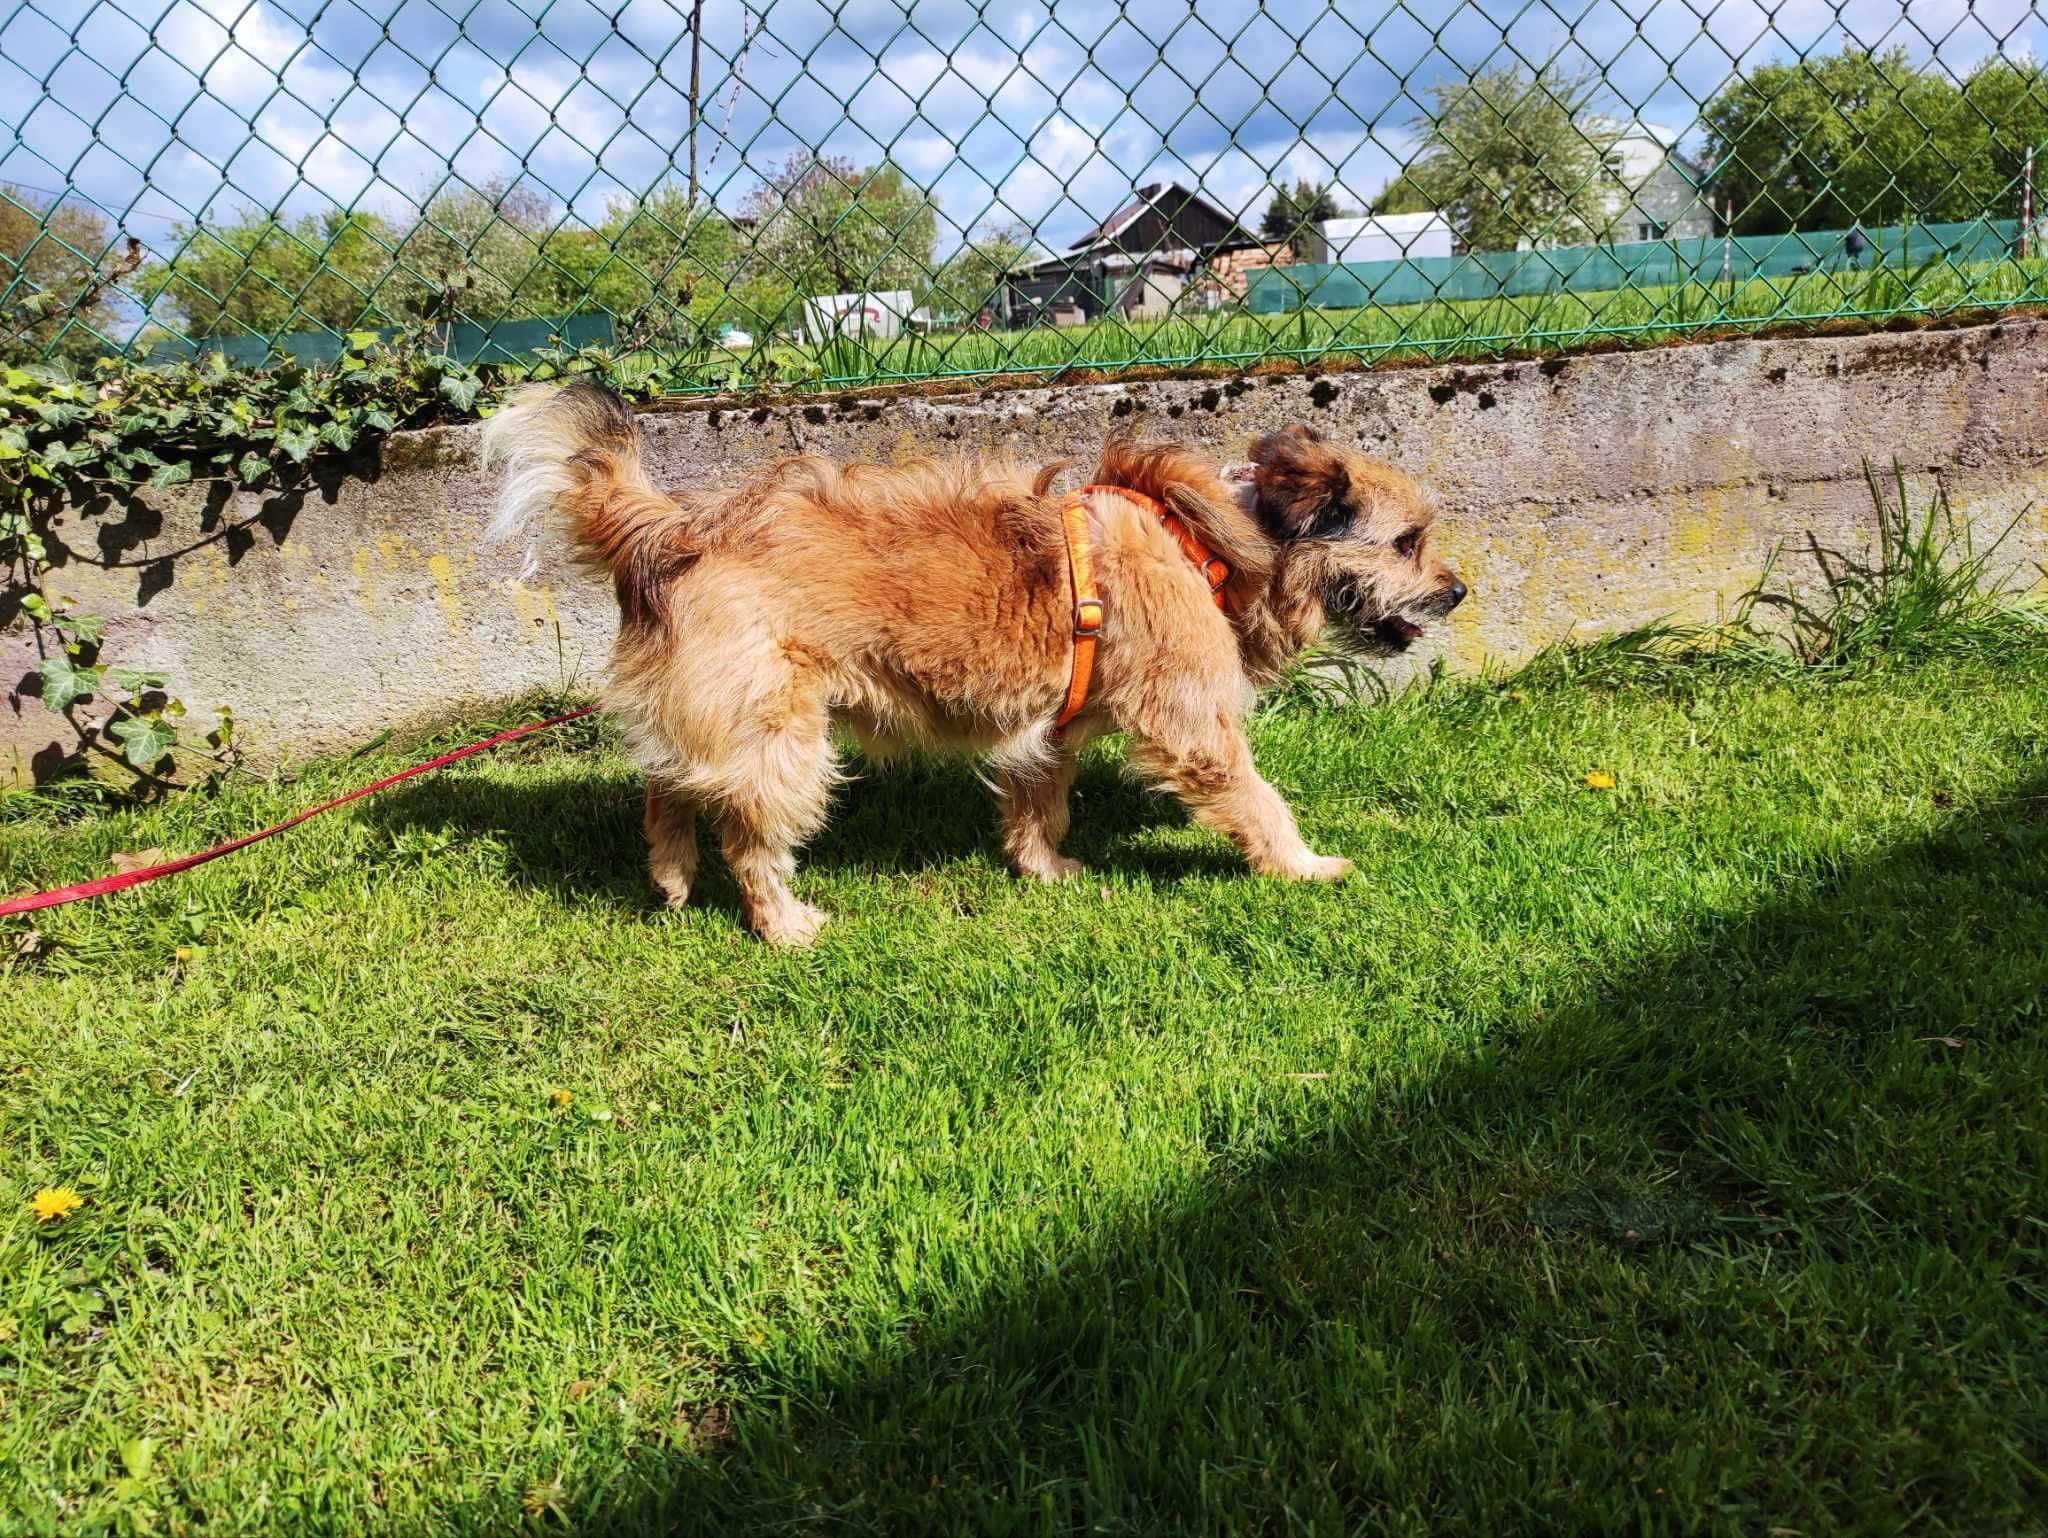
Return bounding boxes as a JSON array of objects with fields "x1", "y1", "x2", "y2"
[{"x1": 1374, "y1": 66, "x2": 1620, "y2": 250}]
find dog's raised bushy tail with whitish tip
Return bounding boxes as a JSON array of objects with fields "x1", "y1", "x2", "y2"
[{"x1": 483, "y1": 379, "x2": 694, "y2": 606}]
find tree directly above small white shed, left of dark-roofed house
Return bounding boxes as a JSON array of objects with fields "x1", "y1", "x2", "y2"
[{"x1": 741, "y1": 152, "x2": 938, "y2": 299}]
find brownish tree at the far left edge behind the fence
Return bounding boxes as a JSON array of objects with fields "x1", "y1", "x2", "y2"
[{"x1": 0, "y1": 182, "x2": 121, "y2": 356}]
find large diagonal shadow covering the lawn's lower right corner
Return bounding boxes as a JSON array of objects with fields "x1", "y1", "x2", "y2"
[{"x1": 524, "y1": 776, "x2": 2048, "y2": 1534}]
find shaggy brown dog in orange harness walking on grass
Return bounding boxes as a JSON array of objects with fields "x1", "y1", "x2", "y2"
[{"x1": 483, "y1": 385, "x2": 1464, "y2": 944}]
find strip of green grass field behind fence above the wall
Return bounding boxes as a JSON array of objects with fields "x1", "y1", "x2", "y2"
[{"x1": 659, "y1": 258, "x2": 2048, "y2": 393}]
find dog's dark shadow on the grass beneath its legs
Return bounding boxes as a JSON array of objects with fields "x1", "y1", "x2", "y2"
[{"x1": 365, "y1": 758, "x2": 1243, "y2": 920}]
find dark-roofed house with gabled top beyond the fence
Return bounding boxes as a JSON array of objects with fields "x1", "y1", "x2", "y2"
[{"x1": 1004, "y1": 182, "x2": 1260, "y2": 326}]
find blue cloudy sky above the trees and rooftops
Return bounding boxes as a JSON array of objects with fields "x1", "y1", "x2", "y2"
[{"x1": 0, "y1": 0, "x2": 2048, "y2": 274}]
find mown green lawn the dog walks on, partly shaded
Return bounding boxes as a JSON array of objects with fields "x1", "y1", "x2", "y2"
[{"x1": 0, "y1": 627, "x2": 2048, "y2": 1534}]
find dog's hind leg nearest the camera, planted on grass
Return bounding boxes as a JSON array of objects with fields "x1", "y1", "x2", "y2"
[{"x1": 719, "y1": 698, "x2": 834, "y2": 946}]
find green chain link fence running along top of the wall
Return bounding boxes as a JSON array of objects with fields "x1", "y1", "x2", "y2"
[{"x1": 0, "y1": 0, "x2": 2048, "y2": 391}]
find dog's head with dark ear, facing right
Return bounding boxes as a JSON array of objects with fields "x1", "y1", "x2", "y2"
[{"x1": 1251, "y1": 426, "x2": 1464, "y2": 651}]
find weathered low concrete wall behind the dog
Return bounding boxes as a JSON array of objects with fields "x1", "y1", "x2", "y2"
[{"x1": 0, "y1": 319, "x2": 2048, "y2": 776}]
